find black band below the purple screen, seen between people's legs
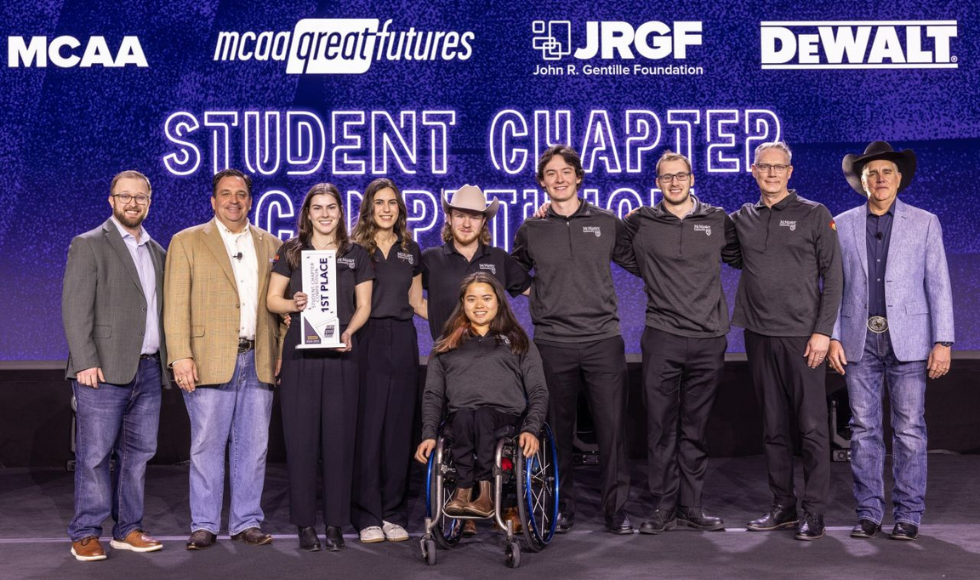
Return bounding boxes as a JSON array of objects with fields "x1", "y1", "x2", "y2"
[{"x1": 0, "y1": 351, "x2": 980, "y2": 466}]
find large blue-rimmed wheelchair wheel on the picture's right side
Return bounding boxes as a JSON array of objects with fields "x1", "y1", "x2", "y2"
[{"x1": 514, "y1": 424, "x2": 558, "y2": 562}]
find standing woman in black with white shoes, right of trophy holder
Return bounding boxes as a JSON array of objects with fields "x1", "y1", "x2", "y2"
[{"x1": 351, "y1": 177, "x2": 422, "y2": 543}]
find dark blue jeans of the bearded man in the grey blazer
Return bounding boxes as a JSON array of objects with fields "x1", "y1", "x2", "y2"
[{"x1": 68, "y1": 358, "x2": 161, "y2": 542}]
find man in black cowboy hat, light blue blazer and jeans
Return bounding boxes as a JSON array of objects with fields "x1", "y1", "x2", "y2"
[{"x1": 828, "y1": 141, "x2": 953, "y2": 540}]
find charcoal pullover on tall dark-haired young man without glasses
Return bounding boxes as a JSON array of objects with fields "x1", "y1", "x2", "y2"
[{"x1": 511, "y1": 200, "x2": 639, "y2": 344}]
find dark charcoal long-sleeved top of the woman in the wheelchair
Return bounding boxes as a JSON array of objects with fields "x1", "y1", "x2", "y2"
[{"x1": 422, "y1": 335, "x2": 548, "y2": 439}]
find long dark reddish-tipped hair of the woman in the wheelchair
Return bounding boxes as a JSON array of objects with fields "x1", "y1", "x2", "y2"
[{"x1": 433, "y1": 272, "x2": 528, "y2": 355}]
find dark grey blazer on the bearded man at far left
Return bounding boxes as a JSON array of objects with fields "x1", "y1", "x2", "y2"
[{"x1": 61, "y1": 218, "x2": 170, "y2": 388}]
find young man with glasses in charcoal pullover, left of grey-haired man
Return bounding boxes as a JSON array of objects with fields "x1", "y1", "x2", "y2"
[{"x1": 623, "y1": 150, "x2": 741, "y2": 534}]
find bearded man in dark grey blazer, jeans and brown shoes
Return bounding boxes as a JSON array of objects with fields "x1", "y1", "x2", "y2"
[{"x1": 61, "y1": 171, "x2": 169, "y2": 562}]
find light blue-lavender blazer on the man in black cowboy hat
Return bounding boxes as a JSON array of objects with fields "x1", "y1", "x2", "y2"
[{"x1": 833, "y1": 199, "x2": 954, "y2": 362}]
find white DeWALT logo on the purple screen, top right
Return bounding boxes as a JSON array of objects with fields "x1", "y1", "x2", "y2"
[{"x1": 760, "y1": 20, "x2": 958, "y2": 69}]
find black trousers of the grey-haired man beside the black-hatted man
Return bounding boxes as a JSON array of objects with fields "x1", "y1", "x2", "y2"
[{"x1": 745, "y1": 330, "x2": 830, "y2": 514}]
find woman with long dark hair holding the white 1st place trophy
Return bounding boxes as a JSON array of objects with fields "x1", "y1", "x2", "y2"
[{"x1": 266, "y1": 183, "x2": 374, "y2": 551}]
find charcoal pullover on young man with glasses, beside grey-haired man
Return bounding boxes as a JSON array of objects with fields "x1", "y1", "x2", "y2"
[{"x1": 623, "y1": 195, "x2": 742, "y2": 338}]
